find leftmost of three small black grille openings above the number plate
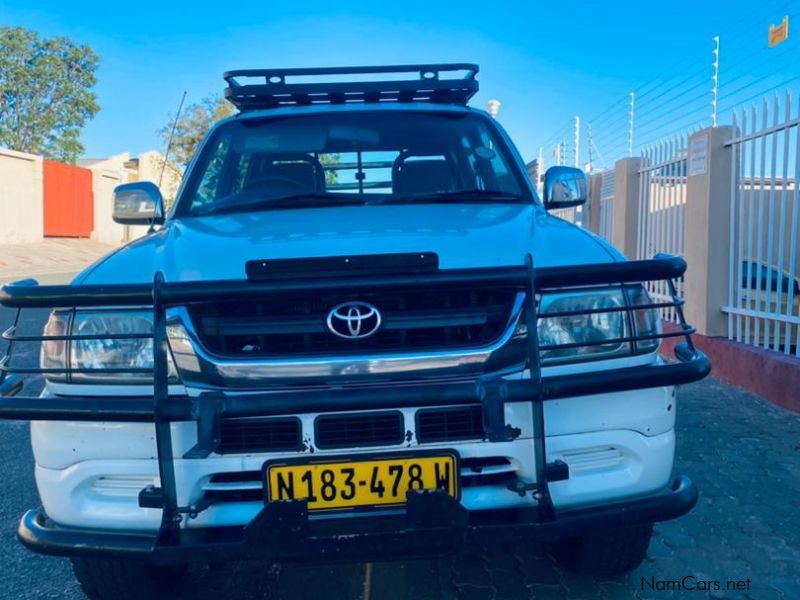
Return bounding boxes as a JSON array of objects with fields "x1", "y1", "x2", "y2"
[{"x1": 217, "y1": 418, "x2": 302, "y2": 454}]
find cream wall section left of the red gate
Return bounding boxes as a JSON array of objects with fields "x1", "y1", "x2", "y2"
[{"x1": 0, "y1": 148, "x2": 44, "y2": 243}]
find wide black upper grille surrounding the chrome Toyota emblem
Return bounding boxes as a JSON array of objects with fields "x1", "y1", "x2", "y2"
[{"x1": 189, "y1": 288, "x2": 516, "y2": 358}]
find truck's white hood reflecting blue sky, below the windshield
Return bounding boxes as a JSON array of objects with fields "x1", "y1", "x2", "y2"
[{"x1": 75, "y1": 204, "x2": 622, "y2": 283}]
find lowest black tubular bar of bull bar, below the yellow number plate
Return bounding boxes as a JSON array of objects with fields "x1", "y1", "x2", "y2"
[{"x1": 18, "y1": 477, "x2": 698, "y2": 564}]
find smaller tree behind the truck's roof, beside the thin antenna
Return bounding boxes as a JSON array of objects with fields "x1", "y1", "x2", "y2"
[{"x1": 158, "y1": 95, "x2": 236, "y2": 166}]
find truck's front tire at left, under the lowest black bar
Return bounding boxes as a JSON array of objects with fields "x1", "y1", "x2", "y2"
[{"x1": 72, "y1": 558, "x2": 188, "y2": 600}]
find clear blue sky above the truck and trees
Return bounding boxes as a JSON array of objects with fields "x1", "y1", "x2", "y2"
[{"x1": 0, "y1": 0, "x2": 800, "y2": 159}]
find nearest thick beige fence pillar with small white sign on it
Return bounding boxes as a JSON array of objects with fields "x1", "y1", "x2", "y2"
[{"x1": 684, "y1": 126, "x2": 733, "y2": 336}]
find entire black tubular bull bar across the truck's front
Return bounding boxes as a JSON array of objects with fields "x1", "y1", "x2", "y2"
[{"x1": 0, "y1": 255, "x2": 710, "y2": 561}]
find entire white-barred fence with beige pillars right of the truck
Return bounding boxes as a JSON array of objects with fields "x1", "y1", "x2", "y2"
[{"x1": 587, "y1": 92, "x2": 800, "y2": 356}]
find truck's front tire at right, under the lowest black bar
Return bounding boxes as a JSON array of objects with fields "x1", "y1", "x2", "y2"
[{"x1": 551, "y1": 523, "x2": 653, "y2": 575}]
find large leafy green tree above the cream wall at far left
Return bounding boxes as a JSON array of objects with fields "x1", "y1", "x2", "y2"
[{"x1": 0, "y1": 27, "x2": 100, "y2": 162}]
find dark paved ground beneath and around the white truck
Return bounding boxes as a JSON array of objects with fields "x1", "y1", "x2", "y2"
[{"x1": 0, "y1": 311, "x2": 800, "y2": 600}]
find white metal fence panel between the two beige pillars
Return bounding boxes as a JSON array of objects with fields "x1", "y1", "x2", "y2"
[{"x1": 636, "y1": 135, "x2": 688, "y2": 322}]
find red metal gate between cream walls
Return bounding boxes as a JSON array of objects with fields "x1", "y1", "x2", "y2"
[{"x1": 44, "y1": 160, "x2": 94, "y2": 237}]
